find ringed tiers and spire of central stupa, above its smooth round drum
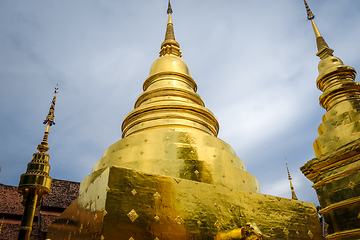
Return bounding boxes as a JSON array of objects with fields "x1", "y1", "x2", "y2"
[{"x1": 122, "y1": 2, "x2": 219, "y2": 137}]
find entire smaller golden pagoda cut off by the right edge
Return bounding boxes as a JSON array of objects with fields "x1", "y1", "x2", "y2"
[{"x1": 301, "y1": 0, "x2": 360, "y2": 240}]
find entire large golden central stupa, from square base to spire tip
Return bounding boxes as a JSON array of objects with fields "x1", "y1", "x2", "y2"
[{"x1": 47, "y1": 3, "x2": 323, "y2": 240}]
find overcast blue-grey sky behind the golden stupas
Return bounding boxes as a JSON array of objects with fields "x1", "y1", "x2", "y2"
[{"x1": 0, "y1": 0, "x2": 360, "y2": 204}]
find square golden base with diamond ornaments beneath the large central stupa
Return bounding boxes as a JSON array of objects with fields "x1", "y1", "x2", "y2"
[{"x1": 47, "y1": 166, "x2": 323, "y2": 240}]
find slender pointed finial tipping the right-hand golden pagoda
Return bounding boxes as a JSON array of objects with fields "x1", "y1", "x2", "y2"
[{"x1": 304, "y1": 0, "x2": 334, "y2": 59}]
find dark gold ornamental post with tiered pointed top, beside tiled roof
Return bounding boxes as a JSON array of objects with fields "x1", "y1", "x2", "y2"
[{"x1": 18, "y1": 86, "x2": 58, "y2": 240}]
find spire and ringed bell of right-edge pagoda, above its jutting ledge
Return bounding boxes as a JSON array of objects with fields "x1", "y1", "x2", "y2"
[{"x1": 304, "y1": 0, "x2": 360, "y2": 157}]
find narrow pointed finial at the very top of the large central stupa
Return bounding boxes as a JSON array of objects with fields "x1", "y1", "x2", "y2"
[{"x1": 159, "y1": 0, "x2": 181, "y2": 57}]
